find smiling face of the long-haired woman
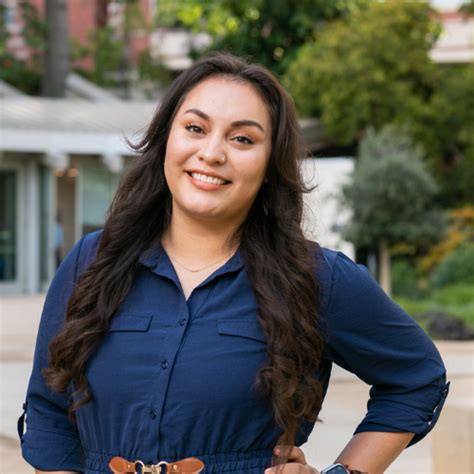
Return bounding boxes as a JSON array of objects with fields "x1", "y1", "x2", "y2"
[{"x1": 164, "y1": 77, "x2": 272, "y2": 226}]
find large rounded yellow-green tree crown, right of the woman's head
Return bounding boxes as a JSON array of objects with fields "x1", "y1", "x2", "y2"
[{"x1": 284, "y1": 0, "x2": 439, "y2": 144}]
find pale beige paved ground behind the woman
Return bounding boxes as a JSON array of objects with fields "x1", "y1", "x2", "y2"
[{"x1": 0, "y1": 296, "x2": 474, "y2": 474}]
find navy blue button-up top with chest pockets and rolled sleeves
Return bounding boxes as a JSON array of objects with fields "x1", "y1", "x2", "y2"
[{"x1": 19, "y1": 232, "x2": 448, "y2": 474}]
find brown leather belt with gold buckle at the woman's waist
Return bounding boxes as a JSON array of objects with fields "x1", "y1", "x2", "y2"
[{"x1": 109, "y1": 456, "x2": 204, "y2": 474}]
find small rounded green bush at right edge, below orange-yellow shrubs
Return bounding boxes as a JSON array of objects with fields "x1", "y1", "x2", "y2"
[{"x1": 430, "y1": 243, "x2": 474, "y2": 288}]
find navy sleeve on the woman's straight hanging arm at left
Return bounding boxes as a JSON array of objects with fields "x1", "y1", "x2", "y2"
[{"x1": 18, "y1": 239, "x2": 83, "y2": 472}]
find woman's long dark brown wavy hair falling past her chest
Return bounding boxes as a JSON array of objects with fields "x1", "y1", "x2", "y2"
[{"x1": 43, "y1": 54, "x2": 323, "y2": 456}]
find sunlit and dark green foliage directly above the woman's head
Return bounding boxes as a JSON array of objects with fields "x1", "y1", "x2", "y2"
[{"x1": 157, "y1": 0, "x2": 367, "y2": 73}]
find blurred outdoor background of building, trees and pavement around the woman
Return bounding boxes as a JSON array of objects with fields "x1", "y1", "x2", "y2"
[{"x1": 0, "y1": 0, "x2": 474, "y2": 473}]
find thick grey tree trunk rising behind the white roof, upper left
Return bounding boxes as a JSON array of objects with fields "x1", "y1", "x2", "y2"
[{"x1": 42, "y1": 0, "x2": 69, "y2": 97}]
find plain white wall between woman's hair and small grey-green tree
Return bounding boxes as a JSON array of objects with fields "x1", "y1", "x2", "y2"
[{"x1": 301, "y1": 158, "x2": 355, "y2": 259}]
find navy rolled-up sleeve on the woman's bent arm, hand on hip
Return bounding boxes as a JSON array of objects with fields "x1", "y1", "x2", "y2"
[{"x1": 325, "y1": 253, "x2": 449, "y2": 445}]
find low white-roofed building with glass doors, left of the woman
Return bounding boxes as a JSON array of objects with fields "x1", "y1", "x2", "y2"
[{"x1": 0, "y1": 96, "x2": 156, "y2": 293}]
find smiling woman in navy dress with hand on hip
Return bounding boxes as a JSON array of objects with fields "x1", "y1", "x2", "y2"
[{"x1": 18, "y1": 55, "x2": 447, "y2": 474}]
